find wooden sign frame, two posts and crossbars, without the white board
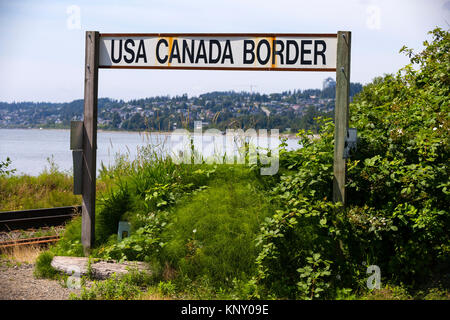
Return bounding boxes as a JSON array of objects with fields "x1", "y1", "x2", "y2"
[{"x1": 81, "y1": 31, "x2": 351, "y2": 255}]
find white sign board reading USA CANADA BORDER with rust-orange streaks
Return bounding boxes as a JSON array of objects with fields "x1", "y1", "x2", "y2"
[{"x1": 99, "y1": 34, "x2": 337, "y2": 71}]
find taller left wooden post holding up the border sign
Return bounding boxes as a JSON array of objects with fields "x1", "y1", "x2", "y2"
[{"x1": 81, "y1": 31, "x2": 99, "y2": 255}]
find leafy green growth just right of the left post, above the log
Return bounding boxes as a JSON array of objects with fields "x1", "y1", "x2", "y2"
[{"x1": 95, "y1": 162, "x2": 215, "y2": 261}]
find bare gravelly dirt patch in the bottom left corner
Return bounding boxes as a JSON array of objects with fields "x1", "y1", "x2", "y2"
[{"x1": 0, "y1": 263, "x2": 80, "y2": 300}]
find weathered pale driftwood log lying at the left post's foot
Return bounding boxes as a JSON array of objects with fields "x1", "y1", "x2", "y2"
[{"x1": 51, "y1": 256, "x2": 150, "y2": 279}]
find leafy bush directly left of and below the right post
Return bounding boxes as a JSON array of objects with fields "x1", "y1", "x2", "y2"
[{"x1": 251, "y1": 119, "x2": 349, "y2": 298}]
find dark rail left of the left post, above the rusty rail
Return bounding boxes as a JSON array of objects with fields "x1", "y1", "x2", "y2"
[{"x1": 0, "y1": 206, "x2": 81, "y2": 231}]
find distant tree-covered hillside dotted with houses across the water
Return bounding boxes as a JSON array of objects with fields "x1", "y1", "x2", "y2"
[{"x1": 0, "y1": 83, "x2": 362, "y2": 132}]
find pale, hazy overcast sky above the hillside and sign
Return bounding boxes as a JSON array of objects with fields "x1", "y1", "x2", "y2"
[{"x1": 0, "y1": 0, "x2": 450, "y2": 102}]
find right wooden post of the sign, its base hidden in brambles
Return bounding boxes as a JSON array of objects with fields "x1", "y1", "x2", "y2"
[{"x1": 333, "y1": 31, "x2": 351, "y2": 204}]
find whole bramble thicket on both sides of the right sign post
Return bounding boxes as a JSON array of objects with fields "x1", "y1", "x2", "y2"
[{"x1": 253, "y1": 29, "x2": 450, "y2": 299}]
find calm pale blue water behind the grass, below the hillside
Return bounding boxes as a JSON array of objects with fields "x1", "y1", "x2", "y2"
[{"x1": 0, "y1": 129, "x2": 299, "y2": 176}]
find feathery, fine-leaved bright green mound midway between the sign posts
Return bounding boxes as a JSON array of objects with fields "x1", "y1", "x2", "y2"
[{"x1": 161, "y1": 166, "x2": 271, "y2": 287}]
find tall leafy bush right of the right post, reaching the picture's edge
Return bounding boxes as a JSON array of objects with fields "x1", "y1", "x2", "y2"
[{"x1": 348, "y1": 29, "x2": 450, "y2": 284}]
